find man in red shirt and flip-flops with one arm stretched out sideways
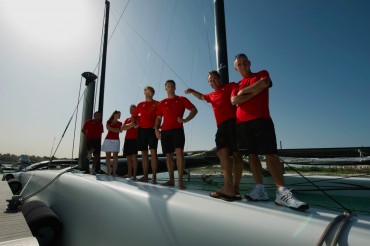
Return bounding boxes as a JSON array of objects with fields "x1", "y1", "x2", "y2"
[{"x1": 185, "y1": 71, "x2": 243, "y2": 201}]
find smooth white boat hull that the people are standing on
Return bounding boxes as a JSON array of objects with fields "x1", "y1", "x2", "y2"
[{"x1": 14, "y1": 170, "x2": 370, "y2": 246}]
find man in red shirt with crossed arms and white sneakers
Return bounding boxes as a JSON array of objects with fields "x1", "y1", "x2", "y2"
[{"x1": 232, "y1": 54, "x2": 309, "y2": 210}]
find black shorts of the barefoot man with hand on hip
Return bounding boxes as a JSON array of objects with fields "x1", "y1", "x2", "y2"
[{"x1": 161, "y1": 127, "x2": 185, "y2": 154}]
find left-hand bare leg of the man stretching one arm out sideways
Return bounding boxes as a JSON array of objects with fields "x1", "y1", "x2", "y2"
[{"x1": 217, "y1": 148, "x2": 235, "y2": 196}]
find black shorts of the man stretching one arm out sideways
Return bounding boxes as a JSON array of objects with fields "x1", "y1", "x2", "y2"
[{"x1": 215, "y1": 118, "x2": 237, "y2": 154}]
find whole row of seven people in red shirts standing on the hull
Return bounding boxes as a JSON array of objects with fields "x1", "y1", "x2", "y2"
[{"x1": 83, "y1": 54, "x2": 309, "y2": 210}]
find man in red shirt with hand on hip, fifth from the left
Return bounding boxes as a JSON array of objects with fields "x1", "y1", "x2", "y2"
[{"x1": 155, "y1": 80, "x2": 198, "y2": 189}]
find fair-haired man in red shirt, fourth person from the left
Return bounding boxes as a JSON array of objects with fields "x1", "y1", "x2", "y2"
[{"x1": 132, "y1": 86, "x2": 159, "y2": 184}]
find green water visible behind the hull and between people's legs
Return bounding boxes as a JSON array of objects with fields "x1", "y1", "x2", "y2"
[{"x1": 152, "y1": 171, "x2": 370, "y2": 216}]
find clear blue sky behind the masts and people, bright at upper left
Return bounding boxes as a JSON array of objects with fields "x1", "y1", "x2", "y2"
[{"x1": 0, "y1": 0, "x2": 370, "y2": 157}]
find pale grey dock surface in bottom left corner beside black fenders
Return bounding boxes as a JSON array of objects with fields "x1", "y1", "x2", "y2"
[{"x1": 0, "y1": 174, "x2": 39, "y2": 246}]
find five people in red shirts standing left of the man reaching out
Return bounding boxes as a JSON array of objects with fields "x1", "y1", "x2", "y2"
[{"x1": 82, "y1": 80, "x2": 198, "y2": 189}]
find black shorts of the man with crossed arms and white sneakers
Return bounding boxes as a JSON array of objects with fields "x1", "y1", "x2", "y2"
[{"x1": 236, "y1": 118, "x2": 277, "y2": 155}]
